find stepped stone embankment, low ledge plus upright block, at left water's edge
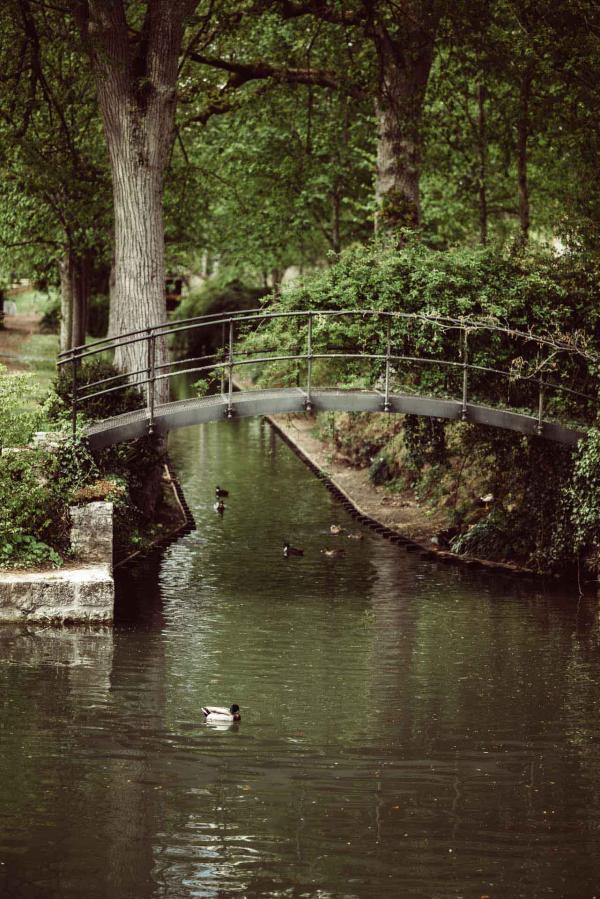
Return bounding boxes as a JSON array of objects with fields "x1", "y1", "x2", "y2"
[{"x1": 0, "y1": 502, "x2": 115, "y2": 624}]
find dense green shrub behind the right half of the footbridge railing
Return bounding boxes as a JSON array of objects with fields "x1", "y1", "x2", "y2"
[{"x1": 247, "y1": 237, "x2": 600, "y2": 421}]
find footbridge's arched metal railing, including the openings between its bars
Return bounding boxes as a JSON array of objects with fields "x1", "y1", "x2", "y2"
[{"x1": 58, "y1": 309, "x2": 598, "y2": 433}]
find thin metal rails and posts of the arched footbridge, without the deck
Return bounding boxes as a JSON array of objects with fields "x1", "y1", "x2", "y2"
[{"x1": 58, "y1": 309, "x2": 599, "y2": 433}]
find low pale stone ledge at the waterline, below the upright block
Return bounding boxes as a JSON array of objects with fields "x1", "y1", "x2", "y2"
[{"x1": 0, "y1": 565, "x2": 115, "y2": 624}]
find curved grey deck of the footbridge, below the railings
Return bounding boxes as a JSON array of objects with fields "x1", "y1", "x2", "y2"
[{"x1": 86, "y1": 387, "x2": 584, "y2": 449}]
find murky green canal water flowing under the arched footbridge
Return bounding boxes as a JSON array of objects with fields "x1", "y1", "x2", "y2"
[{"x1": 0, "y1": 421, "x2": 600, "y2": 899}]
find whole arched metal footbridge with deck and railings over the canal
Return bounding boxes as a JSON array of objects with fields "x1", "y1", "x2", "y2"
[{"x1": 58, "y1": 309, "x2": 597, "y2": 449}]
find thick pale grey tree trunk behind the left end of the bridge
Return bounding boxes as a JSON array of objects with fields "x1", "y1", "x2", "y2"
[{"x1": 71, "y1": 0, "x2": 197, "y2": 402}]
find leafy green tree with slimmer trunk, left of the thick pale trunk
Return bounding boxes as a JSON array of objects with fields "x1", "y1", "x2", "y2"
[{"x1": 0, "y1": 0, "x2": 111, "y2": 349}]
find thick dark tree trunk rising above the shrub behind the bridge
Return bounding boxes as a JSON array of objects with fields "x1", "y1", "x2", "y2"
[{"x1": 370, "y1": 2, "x2": 439, "y2": 231}]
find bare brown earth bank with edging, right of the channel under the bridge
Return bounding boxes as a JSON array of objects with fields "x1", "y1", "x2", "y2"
[{"x1": 266, "y1": 415, "x2": 547, "y2": 577}]
